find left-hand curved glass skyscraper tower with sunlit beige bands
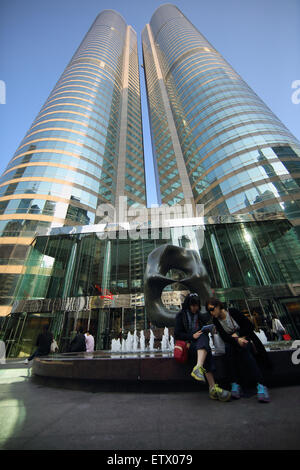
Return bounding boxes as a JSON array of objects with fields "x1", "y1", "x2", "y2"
[{"x1": 0, "y1": 10, "x2": 146, "y2": 315}]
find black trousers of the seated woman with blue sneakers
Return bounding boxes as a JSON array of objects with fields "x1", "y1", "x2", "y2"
[{"x1": 225, "y1": 342, "x2": 264, "y2": 384}]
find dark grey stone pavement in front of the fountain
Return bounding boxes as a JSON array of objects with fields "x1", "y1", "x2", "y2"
[{"x1": 0, "y1": 364, "x2": 300, "y2": 450}]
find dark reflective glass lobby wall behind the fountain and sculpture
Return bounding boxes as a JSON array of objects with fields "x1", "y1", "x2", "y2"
[{"x1": 1, "y1": 219, "x2": 300, "y2": 356}]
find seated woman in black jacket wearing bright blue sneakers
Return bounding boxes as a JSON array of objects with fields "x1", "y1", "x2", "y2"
[{"x1": 206, "y1": 298, "x2": 271, "y2": 402}]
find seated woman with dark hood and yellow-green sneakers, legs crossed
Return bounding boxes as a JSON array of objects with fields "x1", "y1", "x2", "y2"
[{"x1": 174, "y1": 294, "x2": 230, "y2": 401}]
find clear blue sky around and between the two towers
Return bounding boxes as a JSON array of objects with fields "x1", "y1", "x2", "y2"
[{"x1": 0, "y1": 0, "x2": 300, "y2": 205}]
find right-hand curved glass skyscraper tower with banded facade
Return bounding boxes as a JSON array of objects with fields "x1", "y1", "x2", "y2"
[{"x1": 142, "y1": 4, "x2": 300, "y2": 220}]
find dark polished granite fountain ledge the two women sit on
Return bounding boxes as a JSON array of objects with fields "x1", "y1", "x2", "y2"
[{"x1": 32, "y1": 349, "x2": 300, "y2": 391}]
